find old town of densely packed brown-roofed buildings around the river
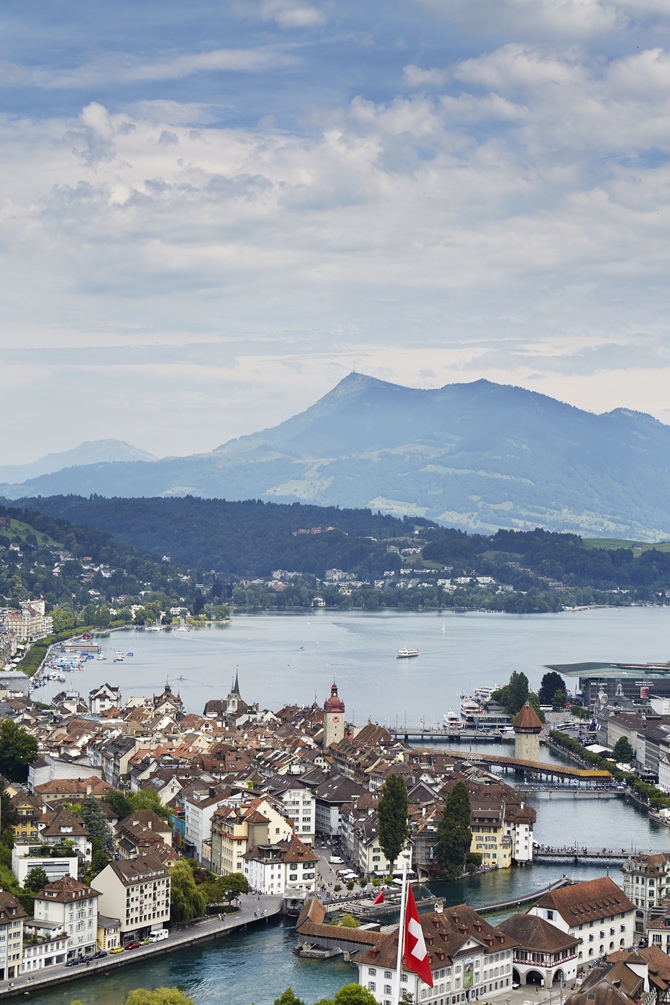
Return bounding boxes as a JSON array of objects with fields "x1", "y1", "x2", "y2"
[{"x1": 0, "y1": 619, "x2": 670, "y2": 1005}]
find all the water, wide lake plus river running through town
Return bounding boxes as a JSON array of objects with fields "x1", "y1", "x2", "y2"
[{"x1": 35, "y1": 608, "x2": 670, "y2": 1005}]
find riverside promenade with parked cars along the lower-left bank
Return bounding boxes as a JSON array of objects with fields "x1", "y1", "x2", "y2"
[{"x1": 0, "y1": 894, "x2": 281, "y2": 998}]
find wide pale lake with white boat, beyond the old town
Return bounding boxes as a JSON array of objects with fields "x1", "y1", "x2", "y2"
[{"x1": 35, "y1": 607, "x2": 670, "y2": 726}]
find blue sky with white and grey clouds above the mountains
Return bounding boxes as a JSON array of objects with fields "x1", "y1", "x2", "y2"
[{"x1": 0, "y1": 0, "x2": 670, "y2": 463}]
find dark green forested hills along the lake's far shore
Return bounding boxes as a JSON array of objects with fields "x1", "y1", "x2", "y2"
[{"x1": 7, "y1": 495, "x2": 670, "y2": 603}]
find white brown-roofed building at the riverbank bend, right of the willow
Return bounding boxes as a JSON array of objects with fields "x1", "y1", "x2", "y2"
[{"x1": 244, "y1": 835, "x2": 318, "y2": 895}]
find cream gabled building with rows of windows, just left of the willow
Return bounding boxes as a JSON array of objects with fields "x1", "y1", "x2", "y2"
[{"x1": 93, "y1": 855, "x2": 170, "y2": 944}]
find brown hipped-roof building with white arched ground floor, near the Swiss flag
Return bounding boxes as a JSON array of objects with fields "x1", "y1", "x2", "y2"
[{"x1": 498, "y1": 915, "x2": 581, "y2": 988}]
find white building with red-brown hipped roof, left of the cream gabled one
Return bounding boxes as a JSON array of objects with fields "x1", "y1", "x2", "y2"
[{"x1": 34, "y1": 876, "x2": 99, "y2": 960}]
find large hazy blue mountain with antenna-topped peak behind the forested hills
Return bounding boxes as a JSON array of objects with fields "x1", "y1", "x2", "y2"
[{"x1": 0, "y1": 374, "x2": 670, "y2": 541}]
